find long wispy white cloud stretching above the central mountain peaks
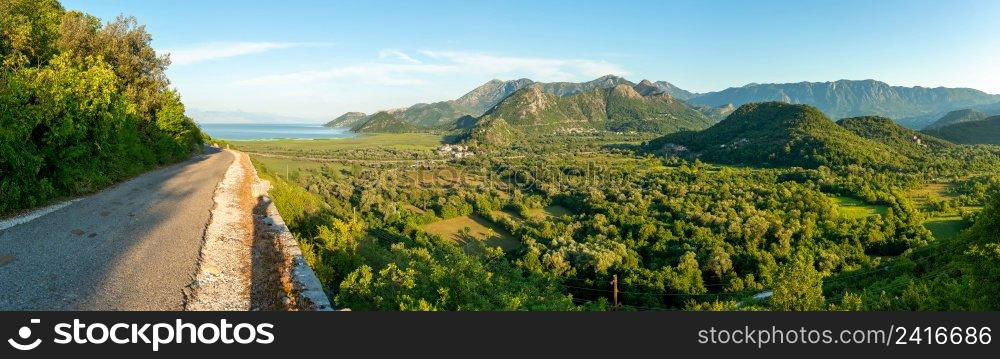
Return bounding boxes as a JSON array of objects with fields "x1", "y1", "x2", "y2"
[{"x1": 237, "y1": 50, "x2": 628, "y2": 86}]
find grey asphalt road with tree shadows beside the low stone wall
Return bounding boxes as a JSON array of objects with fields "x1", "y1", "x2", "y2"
[{"x1": 0, "y1": 149, "x2": 234, "y2": 310}]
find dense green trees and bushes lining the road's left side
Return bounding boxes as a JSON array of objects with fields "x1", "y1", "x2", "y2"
[{"x1": 0, "y1": 0, "x2": 202, "y2": 214}]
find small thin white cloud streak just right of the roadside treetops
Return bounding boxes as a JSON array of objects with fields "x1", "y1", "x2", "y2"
[{"x1": 163, "y1": 42, "x2": 321, "y2": 65}]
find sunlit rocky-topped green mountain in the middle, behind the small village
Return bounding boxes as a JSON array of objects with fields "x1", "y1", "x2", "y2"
[{"x1": 469, "y1": 82, "x2": 714, "y2": 145}]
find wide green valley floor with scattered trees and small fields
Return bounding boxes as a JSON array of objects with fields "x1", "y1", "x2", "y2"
[{"x1": 235, "y1": 134, "x2": 996, "y2": 310}]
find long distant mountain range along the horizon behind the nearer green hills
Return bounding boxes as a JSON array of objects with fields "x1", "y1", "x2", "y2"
[{"x1": 327, "y1": 75, "x2": 1000, "y2": 136}]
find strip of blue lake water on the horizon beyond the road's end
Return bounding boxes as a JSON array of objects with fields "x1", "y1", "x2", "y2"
[{"x1": 201, "y1": 123, "x2": 354, "y2": 141}]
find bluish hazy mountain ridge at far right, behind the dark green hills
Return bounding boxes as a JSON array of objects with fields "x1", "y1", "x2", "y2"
[{"x1": 689, "y1": 80, "x2": 1000, "y2": 124}]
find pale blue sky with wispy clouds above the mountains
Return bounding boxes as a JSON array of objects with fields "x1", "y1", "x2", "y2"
[{"x1": 63, "y1": 0, "x2": 1000, "y2": 120}]
